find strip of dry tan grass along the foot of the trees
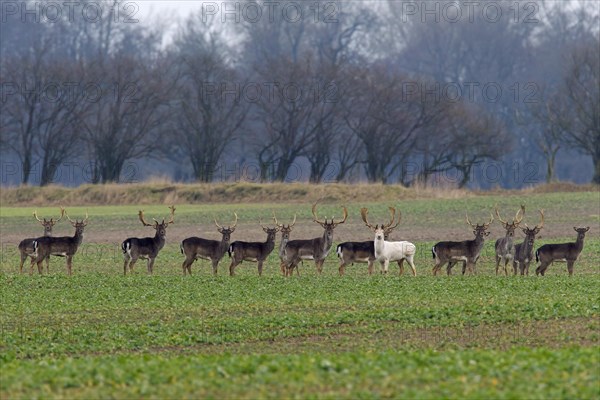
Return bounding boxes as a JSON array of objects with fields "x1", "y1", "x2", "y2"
[{"x1": 0, "y1": 178, "x2": 599, "y2": 206}]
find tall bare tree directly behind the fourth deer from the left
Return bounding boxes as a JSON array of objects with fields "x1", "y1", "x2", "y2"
[{"x1": 175, "y1": 15, "x2": 250, "y2": 182}]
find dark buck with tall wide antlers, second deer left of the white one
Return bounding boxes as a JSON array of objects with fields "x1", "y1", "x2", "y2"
[{"x1": 284, "y1": 203, "x2": 348, "y2": 276}]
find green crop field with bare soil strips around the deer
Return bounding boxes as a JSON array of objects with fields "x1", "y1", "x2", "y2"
[{"x1": 0, "y1": 191, "x2": 600, "y2": 399}]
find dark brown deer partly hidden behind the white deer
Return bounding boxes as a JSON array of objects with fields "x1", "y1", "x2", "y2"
[{"x1": 336, "y1": 207, "x2": 404, "y2": 275}]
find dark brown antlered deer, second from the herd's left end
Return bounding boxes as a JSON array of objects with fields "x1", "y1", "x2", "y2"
[{"x1": 33, "y1": 212, "x2": 89, "y2": 275}]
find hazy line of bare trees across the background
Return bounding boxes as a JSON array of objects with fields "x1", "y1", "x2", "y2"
[{"x1": 0, "y1": 0, "x2": 600, "y2": 187}]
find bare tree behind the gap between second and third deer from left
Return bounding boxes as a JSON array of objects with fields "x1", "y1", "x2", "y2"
[{"x1": 80, "y1": 53, "x2": 174, "y2": 183}]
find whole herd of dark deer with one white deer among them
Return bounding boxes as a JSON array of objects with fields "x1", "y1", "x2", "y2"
[{"x1": 18, "y1": 203, "x2": 590, "y2": 276}]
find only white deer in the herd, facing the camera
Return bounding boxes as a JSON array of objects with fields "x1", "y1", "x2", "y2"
[{"x1": 360, "y1": 208, "x2": 417, "y2": 276}]
